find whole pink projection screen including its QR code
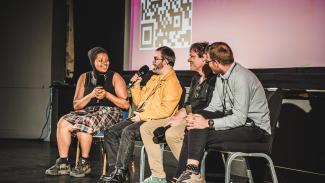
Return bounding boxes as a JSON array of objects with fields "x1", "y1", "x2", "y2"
[{"x1": 124, "y1": 0, "x2": 325, "y2": 70}]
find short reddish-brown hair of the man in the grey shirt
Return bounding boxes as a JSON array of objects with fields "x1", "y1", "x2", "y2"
[{"x1": 207, "y1": 42, "x2": 234, "y2": 65}]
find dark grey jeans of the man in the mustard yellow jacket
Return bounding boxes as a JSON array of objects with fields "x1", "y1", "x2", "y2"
[{"x1": 104, "y1": 119, "x2": 143, "y2": 170}]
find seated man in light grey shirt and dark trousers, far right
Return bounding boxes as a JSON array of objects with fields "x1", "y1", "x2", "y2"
[{"x1": 176, "y1": 42, "x2": 271, "y2": 183}]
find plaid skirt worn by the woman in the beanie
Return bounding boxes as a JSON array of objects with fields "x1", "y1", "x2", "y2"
[{"x1": 63, "y1": 106, "x2": 122, "y2": 135}]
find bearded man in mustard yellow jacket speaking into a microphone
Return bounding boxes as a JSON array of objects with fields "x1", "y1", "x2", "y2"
[{"x1": 101, "y1": 46, "x2": 182, "y2": 183}]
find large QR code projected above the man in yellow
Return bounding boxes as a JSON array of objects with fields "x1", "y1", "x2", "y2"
[{"x1": 140, "y1": 0, "x2": 192, "y2": 50}]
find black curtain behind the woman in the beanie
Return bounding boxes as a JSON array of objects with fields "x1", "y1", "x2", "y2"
[{"x1": 72, "y1": 0, "x2": 125, "y2": 83}]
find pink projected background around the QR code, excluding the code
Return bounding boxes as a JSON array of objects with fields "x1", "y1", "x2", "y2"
[{"x1": 129, "y1": 0, "x2": 325, "y2": 70}]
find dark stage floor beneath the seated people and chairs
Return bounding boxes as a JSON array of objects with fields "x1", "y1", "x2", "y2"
[{"x1": 0, "y1": 139, "x2": 325, "y2": 183}]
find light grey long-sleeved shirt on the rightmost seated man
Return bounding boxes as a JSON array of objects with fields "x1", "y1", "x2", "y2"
[{"x1": 205, "y1": 63, "x2": 271, "y2": 134}]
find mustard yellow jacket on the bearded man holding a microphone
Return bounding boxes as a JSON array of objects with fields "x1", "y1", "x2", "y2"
[{"x1": 131, "y1": 69, "x2": 182, "y2": 121}]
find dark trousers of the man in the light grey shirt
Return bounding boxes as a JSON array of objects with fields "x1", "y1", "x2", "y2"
[{"x1": 175, "y1": 126, "x2": 266, "y2": 177}]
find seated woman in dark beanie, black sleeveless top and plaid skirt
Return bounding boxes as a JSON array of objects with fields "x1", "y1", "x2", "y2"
[{"x1": 45, "y1": 47, "x2": 129, "y2": 177}]
